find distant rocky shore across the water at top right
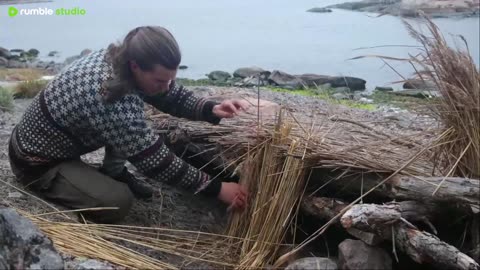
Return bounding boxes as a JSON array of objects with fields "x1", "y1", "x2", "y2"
[{"x1": 308, "y1": 0, "x2": 480, "y2": 18}]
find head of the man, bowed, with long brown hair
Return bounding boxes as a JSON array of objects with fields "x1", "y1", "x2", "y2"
[{"x1": 104, "y1": 26, "x2": 181, "y2": 100}]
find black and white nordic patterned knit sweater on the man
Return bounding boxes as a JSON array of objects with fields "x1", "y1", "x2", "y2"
[{"x1": 9, "y1": 49, "x2": 221, "y2": 196}]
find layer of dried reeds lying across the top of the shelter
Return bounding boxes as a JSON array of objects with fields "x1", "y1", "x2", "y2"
[{"x1": 150, "y1": 106, "x2": 434, "y2": 176}]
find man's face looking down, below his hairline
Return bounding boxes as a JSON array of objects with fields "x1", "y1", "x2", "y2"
[{"x1": 130, "y1": 63, "x2": 177, "y2": 96}]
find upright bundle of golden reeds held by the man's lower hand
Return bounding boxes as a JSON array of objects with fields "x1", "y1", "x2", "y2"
[{"x1": 227, "y1": 110, "x2": 306, "y2": 269}]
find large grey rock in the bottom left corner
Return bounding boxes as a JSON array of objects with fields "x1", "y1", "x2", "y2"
[{"x1": 0, "y1": 208, "x2": 64, "y2": 269}]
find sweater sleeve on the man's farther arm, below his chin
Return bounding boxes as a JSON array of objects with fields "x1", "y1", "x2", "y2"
[{"x1": 143, "y1": 81, "x2": 221, "y2": 124}]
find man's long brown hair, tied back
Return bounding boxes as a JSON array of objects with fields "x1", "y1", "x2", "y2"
[{"x1": 104, "y1": 26, "x2": 182, "y2": 101}]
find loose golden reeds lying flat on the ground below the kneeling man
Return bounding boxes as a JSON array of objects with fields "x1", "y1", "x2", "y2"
[{"x1": 18, "y1": 210, "x2": 243, "y2": 269}]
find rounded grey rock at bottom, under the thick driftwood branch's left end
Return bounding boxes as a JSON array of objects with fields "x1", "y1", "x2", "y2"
[{"x1": 338, "y1": 239, "x2": 392, "y2": 270}]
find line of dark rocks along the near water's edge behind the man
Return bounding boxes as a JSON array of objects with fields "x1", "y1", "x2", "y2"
[{"x1": 0, "y1": 47, "x2": 435, "y2": 103}]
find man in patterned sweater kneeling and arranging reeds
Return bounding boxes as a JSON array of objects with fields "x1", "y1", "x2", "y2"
[{"x1": 9, "y1": 26, "x2": 247, "y2": 222}]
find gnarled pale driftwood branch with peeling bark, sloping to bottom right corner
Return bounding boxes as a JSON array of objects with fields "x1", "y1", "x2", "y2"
[{"x1": 341, "y1": 204, "x2": 480, "y2": 270}]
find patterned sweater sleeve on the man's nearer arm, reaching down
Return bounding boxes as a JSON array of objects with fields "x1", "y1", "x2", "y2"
[{"x1": 97, "y1": 97, "x2": 221, "y2": 196}]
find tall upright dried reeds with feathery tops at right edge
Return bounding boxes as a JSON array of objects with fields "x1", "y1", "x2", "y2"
[{"x1": 405, "y1": 17, "x2": 480, "y2": 179}]
